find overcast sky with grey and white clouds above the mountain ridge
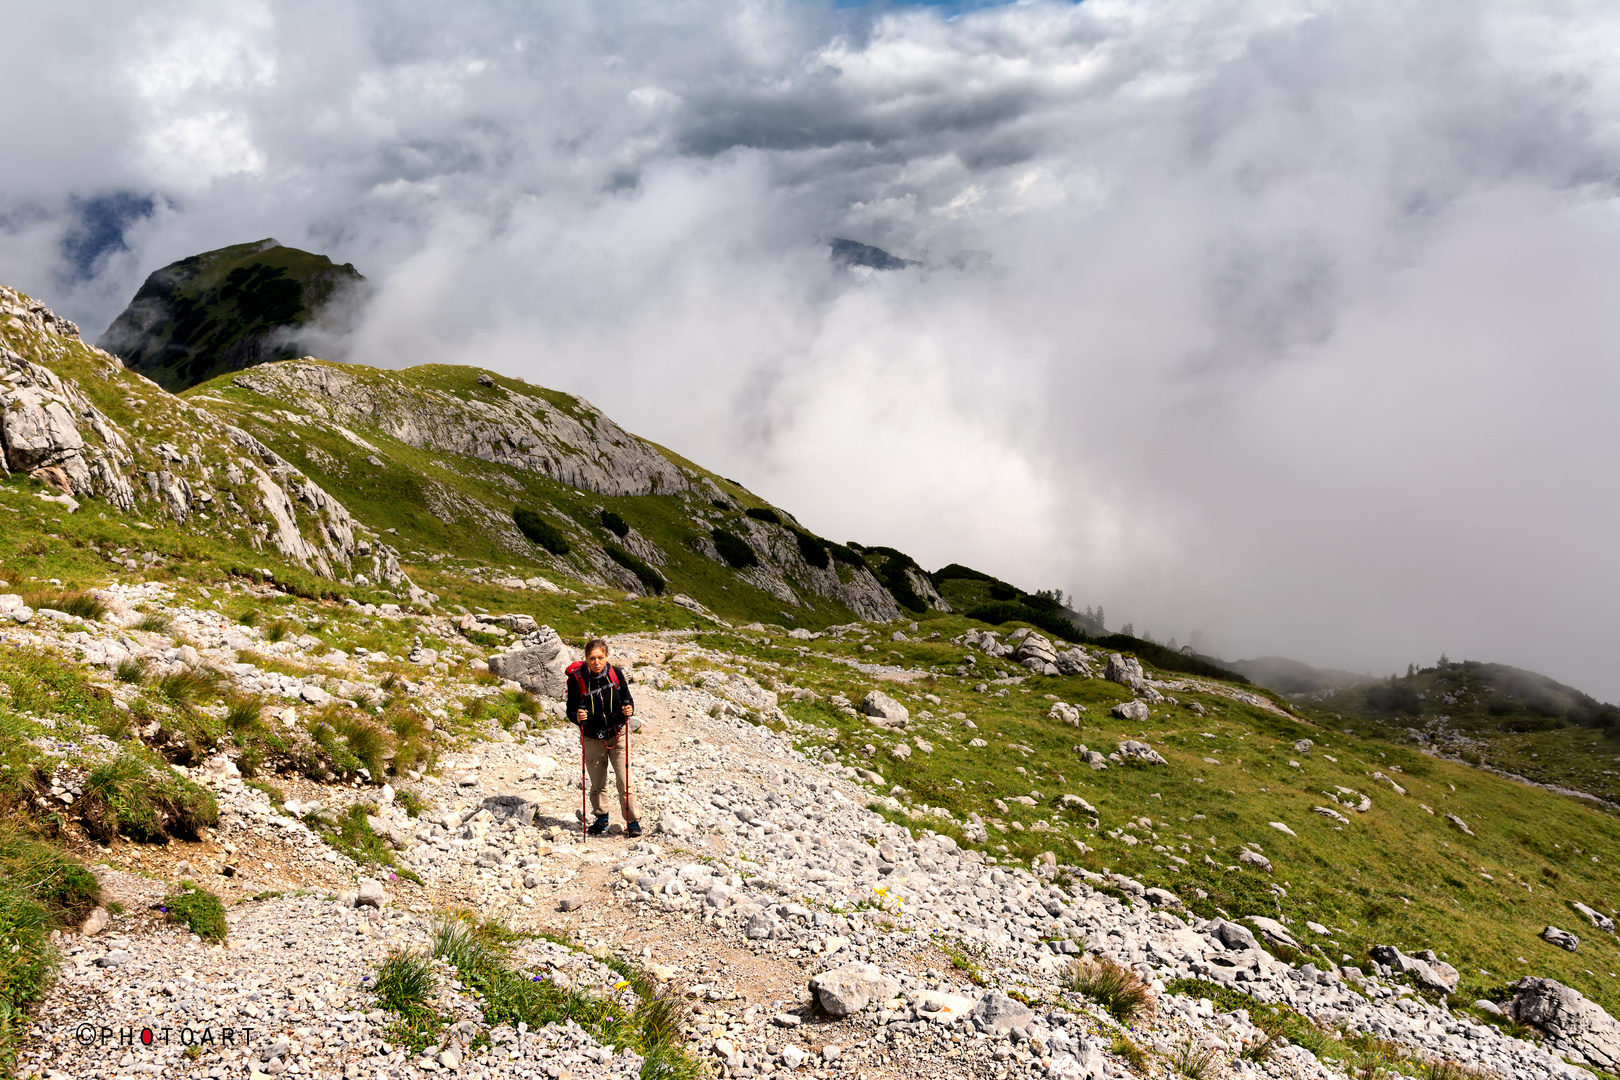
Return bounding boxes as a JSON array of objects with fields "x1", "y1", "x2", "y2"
[{"x1": 0, "y1": 0, "x2": 1620, "y2": 699}]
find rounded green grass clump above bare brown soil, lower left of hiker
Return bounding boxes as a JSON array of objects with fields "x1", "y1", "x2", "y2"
[{"x1": 79, "y1": 751, "x2": 219, "y2": 844}]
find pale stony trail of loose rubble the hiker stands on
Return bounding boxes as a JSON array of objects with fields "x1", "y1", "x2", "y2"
[{"x1": 19, "y1": 625, "x2": 1591, "y2": 1080}]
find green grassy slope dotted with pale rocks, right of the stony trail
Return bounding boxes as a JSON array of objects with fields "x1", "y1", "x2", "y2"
[{"x1": 690, "y1": 617, "x2": 1620, "y2": 1009}]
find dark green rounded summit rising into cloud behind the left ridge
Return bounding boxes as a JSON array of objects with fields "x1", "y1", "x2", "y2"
[{"x1": 97, "y1": 240, "x2": 366, "y2": 392}]
